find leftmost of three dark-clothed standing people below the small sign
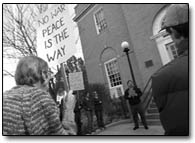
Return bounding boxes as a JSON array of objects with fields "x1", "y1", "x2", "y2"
[{"x1": 74, "y1": 98, "x2": 82, "y2": 135}]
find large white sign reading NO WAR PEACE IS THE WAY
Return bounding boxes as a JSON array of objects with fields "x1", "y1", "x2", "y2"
[{"x1": 37, "y1": 4, "x2": 76, "y2": 69}]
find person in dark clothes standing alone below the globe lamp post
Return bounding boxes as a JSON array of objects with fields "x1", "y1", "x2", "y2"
[{"x1": 125, "y1": 80, "x2": 148, "y2": 130}]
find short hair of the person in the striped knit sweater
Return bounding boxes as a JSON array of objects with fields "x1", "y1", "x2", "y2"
[{"x1": 15, "y1": 56, "x2": 48, "y2": 86}]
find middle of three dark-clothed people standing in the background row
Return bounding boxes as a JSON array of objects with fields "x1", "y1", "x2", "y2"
[{"x1": 83, "y1": 93, "x2": 93, "y2": 134}]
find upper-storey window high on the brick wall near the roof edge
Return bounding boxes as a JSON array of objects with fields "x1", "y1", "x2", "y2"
[{"x1": 94, "y1": 8, "x2": 107, "y2": 34}]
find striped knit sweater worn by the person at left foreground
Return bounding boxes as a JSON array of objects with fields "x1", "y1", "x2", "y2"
[{"x1": 3, "y1": 85, "x2": 75, "y2": 135}]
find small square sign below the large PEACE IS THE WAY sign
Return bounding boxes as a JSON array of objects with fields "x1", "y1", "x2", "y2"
[{"x1": 69, "y1": 72, "x2": 84, "y2": 90}]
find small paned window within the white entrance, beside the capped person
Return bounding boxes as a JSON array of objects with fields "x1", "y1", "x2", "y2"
[{"x1": 166, "y1": 42, "x2": 178, "y2": 60}]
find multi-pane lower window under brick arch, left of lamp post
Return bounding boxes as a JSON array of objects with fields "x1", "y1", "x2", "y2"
[{"x1": 105, "y1": 59, "x2": 122, "y2": 88}]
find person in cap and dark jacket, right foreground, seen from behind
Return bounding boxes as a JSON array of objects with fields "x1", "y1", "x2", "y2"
[{"x1": 152, "y1": 4, "x2": 189, "y2": 136}]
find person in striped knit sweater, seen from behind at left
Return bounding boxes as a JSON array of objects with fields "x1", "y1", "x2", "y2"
[{"x1": 3, "y1": 56, "x2": 75, "y2": 135}]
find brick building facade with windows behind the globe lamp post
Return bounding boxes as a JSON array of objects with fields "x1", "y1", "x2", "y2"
[{"x1": 74, "y1": 4, "x2": 177, "y2": 98}]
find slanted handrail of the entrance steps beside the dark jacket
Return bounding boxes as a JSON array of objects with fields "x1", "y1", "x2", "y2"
[{"x1": 142, "y1": 77, "x2": 152, "y2": 111}]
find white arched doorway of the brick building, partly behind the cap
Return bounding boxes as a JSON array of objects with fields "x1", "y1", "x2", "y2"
[{"x1": 151, "y1": 6, "x2": 178, "y2": 65}]
